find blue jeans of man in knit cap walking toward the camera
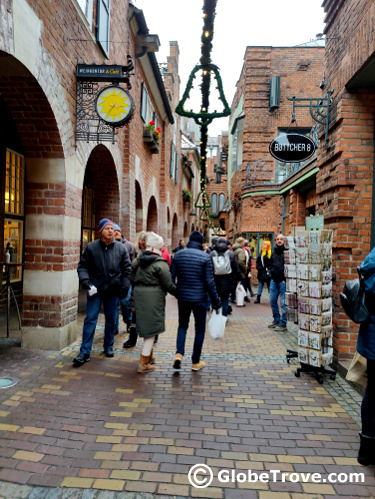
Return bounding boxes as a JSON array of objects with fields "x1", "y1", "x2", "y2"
[{"x1": 80, "y1": 293, "x2": 118, "y2": 354}]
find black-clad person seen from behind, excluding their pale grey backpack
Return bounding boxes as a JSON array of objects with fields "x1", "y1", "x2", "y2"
[{"x1": 210, "y1": 237, "x2": 241, "y2": 317}]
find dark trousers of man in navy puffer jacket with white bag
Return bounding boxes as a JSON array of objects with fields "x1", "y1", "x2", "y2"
[{"x1": 176, "y1": 300, "x2": 207, "y2": 364}]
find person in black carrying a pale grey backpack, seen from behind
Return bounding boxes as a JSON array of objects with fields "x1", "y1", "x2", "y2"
[{"x1": 210, "y1": 237, "x2": 241, "y2": 317}]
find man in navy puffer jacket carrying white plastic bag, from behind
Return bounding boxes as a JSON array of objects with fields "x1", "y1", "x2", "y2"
[{"x1": 171, "y1": 230, "x2": 221, "y2": 371}]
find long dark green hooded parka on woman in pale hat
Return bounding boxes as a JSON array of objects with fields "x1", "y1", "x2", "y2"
[{"x1": 130, "y1": 251, "x2": 177, "y2": 338}]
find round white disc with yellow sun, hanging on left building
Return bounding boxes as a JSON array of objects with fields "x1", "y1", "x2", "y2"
[{"x1": 96, "y1": 86, "x2": 134, "y2": 126}]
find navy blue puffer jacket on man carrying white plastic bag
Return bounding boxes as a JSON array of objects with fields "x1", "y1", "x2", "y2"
[{"x1": 171, "y1": 241, "x2": 219, "y2": 305}]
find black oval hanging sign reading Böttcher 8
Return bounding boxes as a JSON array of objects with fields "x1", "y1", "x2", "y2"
[{"x1": 270, "y1": 133, "x2": 316, "y2": 163}]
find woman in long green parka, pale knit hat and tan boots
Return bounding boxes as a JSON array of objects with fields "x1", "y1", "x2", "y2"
[{"x1": 130, "y1": 232, "x2": 177, "y2": 374}]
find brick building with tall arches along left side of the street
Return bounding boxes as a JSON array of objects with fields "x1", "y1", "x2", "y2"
[{"x1": 0, "y1": 0, "x2": 198, "y2": 349}]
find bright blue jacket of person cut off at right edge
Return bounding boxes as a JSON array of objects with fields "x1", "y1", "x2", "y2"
[{"x1": 357, "y1": 248, "x2": 375, "y2": 360}]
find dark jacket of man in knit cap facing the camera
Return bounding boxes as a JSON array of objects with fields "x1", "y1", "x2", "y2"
[{"x1": 77, "y1": 239, "x2": 130, "y2": 298}]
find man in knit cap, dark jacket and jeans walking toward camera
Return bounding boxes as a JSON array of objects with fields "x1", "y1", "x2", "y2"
[{"x1": 73, "y1": 218, "x2": 130, "y2": 367}]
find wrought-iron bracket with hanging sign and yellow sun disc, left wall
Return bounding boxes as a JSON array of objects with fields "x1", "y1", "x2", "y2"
[{"x1": 76, "y1": 59, "x2": 134, "y2": 144}]
